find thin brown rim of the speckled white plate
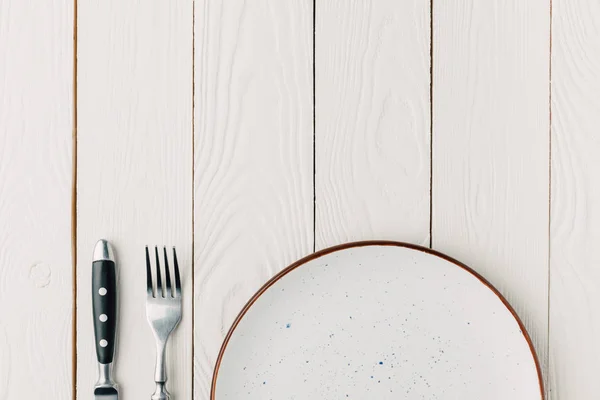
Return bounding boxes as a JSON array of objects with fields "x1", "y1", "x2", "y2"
[{"x1": 210, "y1": 240, "x2": 546, "y2": 400}]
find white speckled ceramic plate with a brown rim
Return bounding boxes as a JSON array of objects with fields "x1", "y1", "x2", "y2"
[{"x1": 211, "y1": 242, "x2": 543, "y2": 400}]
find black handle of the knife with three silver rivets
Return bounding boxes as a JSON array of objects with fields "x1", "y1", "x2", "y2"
[{"x1": 92, "y1": 260, "x2": 117, "y2": 364}]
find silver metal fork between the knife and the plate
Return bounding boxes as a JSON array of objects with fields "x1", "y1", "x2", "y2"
[{"x1": 146, "y1": 246, "x2": 181, "y2": 400}]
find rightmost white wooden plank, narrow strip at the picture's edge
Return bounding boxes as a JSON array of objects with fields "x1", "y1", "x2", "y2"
[{"x1": 550, "y1": 0, "x2": 600, "y2": 400}]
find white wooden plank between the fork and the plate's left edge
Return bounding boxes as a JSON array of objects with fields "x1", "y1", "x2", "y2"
[{"x1": 194, "y1": 0, "x2": 313, "y2": 400}]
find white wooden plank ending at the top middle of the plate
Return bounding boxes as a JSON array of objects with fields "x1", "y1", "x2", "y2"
[{"x1": 315, "y1": 0, "x2": 430, "y2": 249}]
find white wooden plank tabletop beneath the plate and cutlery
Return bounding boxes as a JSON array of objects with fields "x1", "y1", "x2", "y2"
[{"x1": 0, "y1": 0, "x2": 600, "y2": 400}]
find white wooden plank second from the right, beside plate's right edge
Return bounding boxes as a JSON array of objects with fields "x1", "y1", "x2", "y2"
[{"x1": 432, "y1": 0, "x2": 550, "y2": 390}]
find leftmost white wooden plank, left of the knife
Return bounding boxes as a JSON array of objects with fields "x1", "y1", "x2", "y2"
[{"x1": 0, "y1": 0, "x2": 73, "y2": 399}]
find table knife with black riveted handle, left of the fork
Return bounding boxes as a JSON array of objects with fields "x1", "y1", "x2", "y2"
[{"x1": 92, "y1": 240, "x2": 119, "y2": 400}]
